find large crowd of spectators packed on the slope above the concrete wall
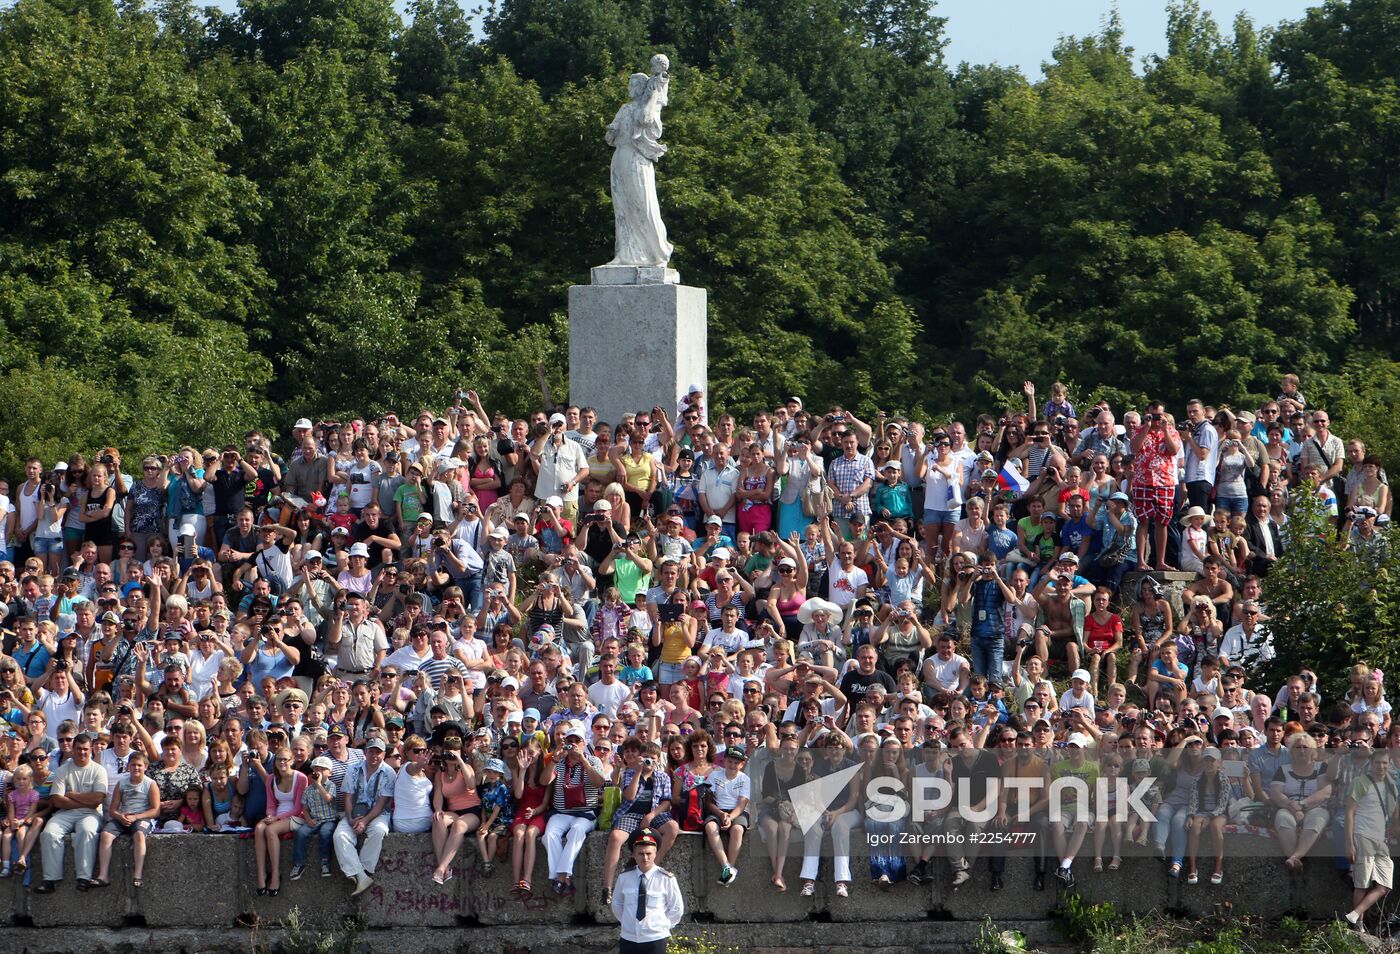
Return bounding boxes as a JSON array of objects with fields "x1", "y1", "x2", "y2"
[{"x1": 0, "y1": 375, "x2": 1400, "y2": 927}]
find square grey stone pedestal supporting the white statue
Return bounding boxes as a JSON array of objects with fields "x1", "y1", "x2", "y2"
[{"x1": 568, "y1": 277, "x2": 708, "y2": 424}]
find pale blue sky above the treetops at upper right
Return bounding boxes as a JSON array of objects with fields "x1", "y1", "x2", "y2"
[{"x1": 937, "y1": 0, "x2": 1319, "y2": 80}]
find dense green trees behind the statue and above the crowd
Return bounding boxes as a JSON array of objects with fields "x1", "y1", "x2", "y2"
[{"x1": 0, "y1": 0, "x2": 1400, "y2": 469}]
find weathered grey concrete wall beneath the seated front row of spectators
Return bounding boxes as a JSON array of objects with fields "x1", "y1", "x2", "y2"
[{"x1": 0, "y1": 834, "x2": 1351, "y2": 954}]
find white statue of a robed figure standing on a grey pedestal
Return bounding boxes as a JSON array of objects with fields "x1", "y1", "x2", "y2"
[{"x1": 608, "y1": 53, "x2": 672, "y2": 268}]
